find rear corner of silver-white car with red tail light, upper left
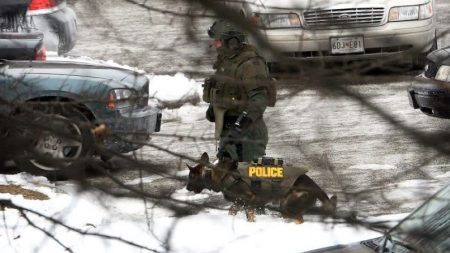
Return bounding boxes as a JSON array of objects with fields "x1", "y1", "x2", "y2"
[{"x1": 26, "y1": 0, "x2": 77, "y2": 54}]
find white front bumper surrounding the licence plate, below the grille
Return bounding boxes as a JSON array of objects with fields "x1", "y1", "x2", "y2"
[{"x1": 261, "y1": 19, "x2": 435, "y2": 62}]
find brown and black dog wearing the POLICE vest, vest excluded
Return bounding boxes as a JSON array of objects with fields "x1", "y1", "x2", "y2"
[{"x1": 186, "y1": 153, "x2": 336, "y2": 221}]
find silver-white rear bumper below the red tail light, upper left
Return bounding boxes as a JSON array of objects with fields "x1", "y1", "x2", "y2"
[{"x1": 28, "y1": 7, "x2": 77, "y2": 54}]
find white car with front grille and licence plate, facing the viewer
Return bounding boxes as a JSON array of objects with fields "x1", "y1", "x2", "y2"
[{"x1": 224, "y1": 0, "x2": 437, "y2": 67}]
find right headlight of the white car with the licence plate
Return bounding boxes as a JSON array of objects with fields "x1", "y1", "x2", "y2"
[{"x1": 389, "y1": 2, "x2": 433, "y2": 22}]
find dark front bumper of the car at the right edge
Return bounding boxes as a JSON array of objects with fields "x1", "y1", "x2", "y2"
[{"x1": 408, "y1": 79, "x2": 450, "y2": 119}]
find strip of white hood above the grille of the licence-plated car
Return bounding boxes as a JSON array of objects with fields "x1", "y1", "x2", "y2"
[{"x1": 248, "y1": 0, "x2": 429, "y2": 9}]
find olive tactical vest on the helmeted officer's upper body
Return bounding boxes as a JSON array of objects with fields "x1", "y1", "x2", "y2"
[{"x1": 203, "y1": 46, "x2": 276, "y2": 113}]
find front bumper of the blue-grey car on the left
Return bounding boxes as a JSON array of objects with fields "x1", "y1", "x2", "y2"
[{"x1": 97, "y1": 106, "x2": 162, "y2": 153}]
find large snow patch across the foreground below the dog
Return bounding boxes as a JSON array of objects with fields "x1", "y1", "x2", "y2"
[{"x1": 0, "y1": 173, "x2": 386, "y2": 253}]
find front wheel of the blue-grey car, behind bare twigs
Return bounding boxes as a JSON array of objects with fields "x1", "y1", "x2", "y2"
[{"x1": 15, "y1": 106, "x2": 94, "y2": 179}]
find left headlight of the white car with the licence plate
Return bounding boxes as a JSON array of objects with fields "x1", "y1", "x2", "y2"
[{"x1": 252, "y1": 13, "x2": 301, "y2": 29}]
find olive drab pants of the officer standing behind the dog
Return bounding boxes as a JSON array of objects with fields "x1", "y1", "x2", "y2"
[{"x1": 217, "y1": 119, "x2": 269, "y2": 162}]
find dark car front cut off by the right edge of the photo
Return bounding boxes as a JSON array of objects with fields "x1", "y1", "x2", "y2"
[{"x1": 408, "y1": 47, "x2": 450, "y2": 119}]
